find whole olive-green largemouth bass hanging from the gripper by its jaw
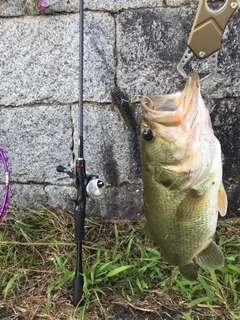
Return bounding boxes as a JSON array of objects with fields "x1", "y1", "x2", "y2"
[{"x1": 141, "y1": 73, "x2": 227, "y2": 280}]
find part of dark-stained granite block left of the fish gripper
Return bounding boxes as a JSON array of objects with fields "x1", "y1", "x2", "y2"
[{"x1": 116, "y1": 7, "x2": 193, "y2": 99}]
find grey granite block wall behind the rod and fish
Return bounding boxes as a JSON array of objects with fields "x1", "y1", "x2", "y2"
[{"x1": 0, "y1": 0, "x2": 240, "y2": 219}]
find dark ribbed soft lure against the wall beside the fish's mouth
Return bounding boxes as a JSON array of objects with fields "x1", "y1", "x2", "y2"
[{"x1": 111, "y1": 87, "x2": 137, "y2": 130}]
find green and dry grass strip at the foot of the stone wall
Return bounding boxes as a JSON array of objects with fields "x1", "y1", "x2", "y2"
[{"x1": 0, "y1": 208, "x2": 240, "y2": 320}]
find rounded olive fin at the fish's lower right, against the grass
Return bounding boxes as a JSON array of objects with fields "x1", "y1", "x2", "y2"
[{"x1": 195, "y1": 240, "x2": 224, "y2": 270}]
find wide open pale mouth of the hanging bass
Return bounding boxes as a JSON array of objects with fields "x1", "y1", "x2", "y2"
[{"x1": 141, "y1": 72, "x2": 200, "y2": 126}]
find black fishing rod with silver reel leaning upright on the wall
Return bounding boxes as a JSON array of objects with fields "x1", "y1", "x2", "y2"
[{"x1": 57, "y1": 0, "x2": 106, "y2": 306}]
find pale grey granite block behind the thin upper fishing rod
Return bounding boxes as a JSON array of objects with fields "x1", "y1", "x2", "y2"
[{"x1": 0, "y1": 12, "x2": 115, "y2": 106}]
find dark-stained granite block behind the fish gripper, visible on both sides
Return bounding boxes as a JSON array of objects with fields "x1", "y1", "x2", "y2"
[{"x1": 116, "y1": 7, "x2": 240, "y2": 99}]
